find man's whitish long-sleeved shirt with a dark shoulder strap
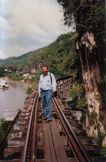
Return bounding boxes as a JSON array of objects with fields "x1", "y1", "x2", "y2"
[{"x1": 39, "y1": 72, "x2": 56, "y2": 95}]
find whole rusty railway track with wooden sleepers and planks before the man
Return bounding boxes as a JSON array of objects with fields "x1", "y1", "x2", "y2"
[{"x1": 0, "y1": 90, "x2": 103, "y2": 162}]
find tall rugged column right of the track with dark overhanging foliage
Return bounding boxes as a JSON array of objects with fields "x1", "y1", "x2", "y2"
[{"x1": 57, "y1": 0, "x2": 105, "y2": 136}]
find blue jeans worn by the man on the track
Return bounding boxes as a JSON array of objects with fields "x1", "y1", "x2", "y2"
[{"x1": 41, "y1": 90, "x2": 53, "y2": 120}]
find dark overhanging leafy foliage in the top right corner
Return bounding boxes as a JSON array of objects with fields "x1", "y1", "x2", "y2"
[{"x1": 57, "y1": 0, "x2": 106, "y2": 76}]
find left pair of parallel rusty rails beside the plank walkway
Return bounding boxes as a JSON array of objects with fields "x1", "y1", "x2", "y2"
[{"x1": 22, "y1": 92, "x2": 38, "y2": 162}]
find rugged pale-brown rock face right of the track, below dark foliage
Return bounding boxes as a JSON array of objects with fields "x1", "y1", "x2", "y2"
[{"x1": 76, "y1": 31, "x2": 104, "y2": 137}]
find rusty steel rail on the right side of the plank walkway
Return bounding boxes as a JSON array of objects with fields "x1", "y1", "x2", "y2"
[{"x1": 53, "y1": 99, "x2": 90, "y2": 162}]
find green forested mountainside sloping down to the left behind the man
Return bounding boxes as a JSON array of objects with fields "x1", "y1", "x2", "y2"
[{"x1": 0, "y1": 33, "x2": 79, "y2": 76}]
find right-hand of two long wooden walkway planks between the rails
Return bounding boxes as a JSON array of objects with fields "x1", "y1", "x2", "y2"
[{"x1": 49, "y1": 121, "x2": 68, "y2": 162}]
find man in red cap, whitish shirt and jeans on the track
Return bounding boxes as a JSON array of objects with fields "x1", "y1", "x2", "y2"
[{"x1": 39, "y1": 66, "x2": 56, "y2": 122}]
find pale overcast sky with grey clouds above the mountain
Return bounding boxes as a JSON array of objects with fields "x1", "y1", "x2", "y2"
[{"x1": 0, "y1": 0, "x2": 72, "y2": 59}]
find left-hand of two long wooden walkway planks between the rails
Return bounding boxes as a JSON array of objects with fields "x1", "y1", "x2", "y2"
[{"x1": 44, "y1": 123, "x2": 58, "y2": 162}]
